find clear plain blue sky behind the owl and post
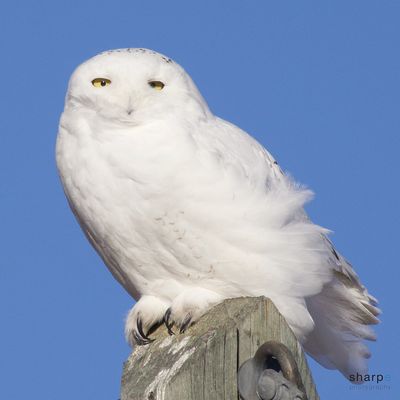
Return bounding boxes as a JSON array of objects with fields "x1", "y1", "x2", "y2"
[{"x1": 0, "y1": 0, "x2": 400, "y2": 400}]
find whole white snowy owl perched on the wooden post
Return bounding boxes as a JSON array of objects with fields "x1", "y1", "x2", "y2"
[{"x1": 56, "y1": 49, "x2": 379, "y2": 377}]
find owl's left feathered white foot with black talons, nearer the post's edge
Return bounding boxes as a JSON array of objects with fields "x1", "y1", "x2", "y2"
[{"x1": 125, "y1": 296, "x2": 168, "y2": 347}]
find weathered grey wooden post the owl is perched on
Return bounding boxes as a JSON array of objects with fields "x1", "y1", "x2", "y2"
[{"x1": 121, "y1": 297, "x2": 319, "y2": 400}]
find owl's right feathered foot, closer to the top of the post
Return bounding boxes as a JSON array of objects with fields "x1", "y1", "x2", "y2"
[{"x1": 164, "y1": 288, "x2": 224, "y2": 335}]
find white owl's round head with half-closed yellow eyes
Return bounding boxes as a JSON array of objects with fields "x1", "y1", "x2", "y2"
[{"x1": 66, "y1": 49, "x2": 208, "y2": 125}]
